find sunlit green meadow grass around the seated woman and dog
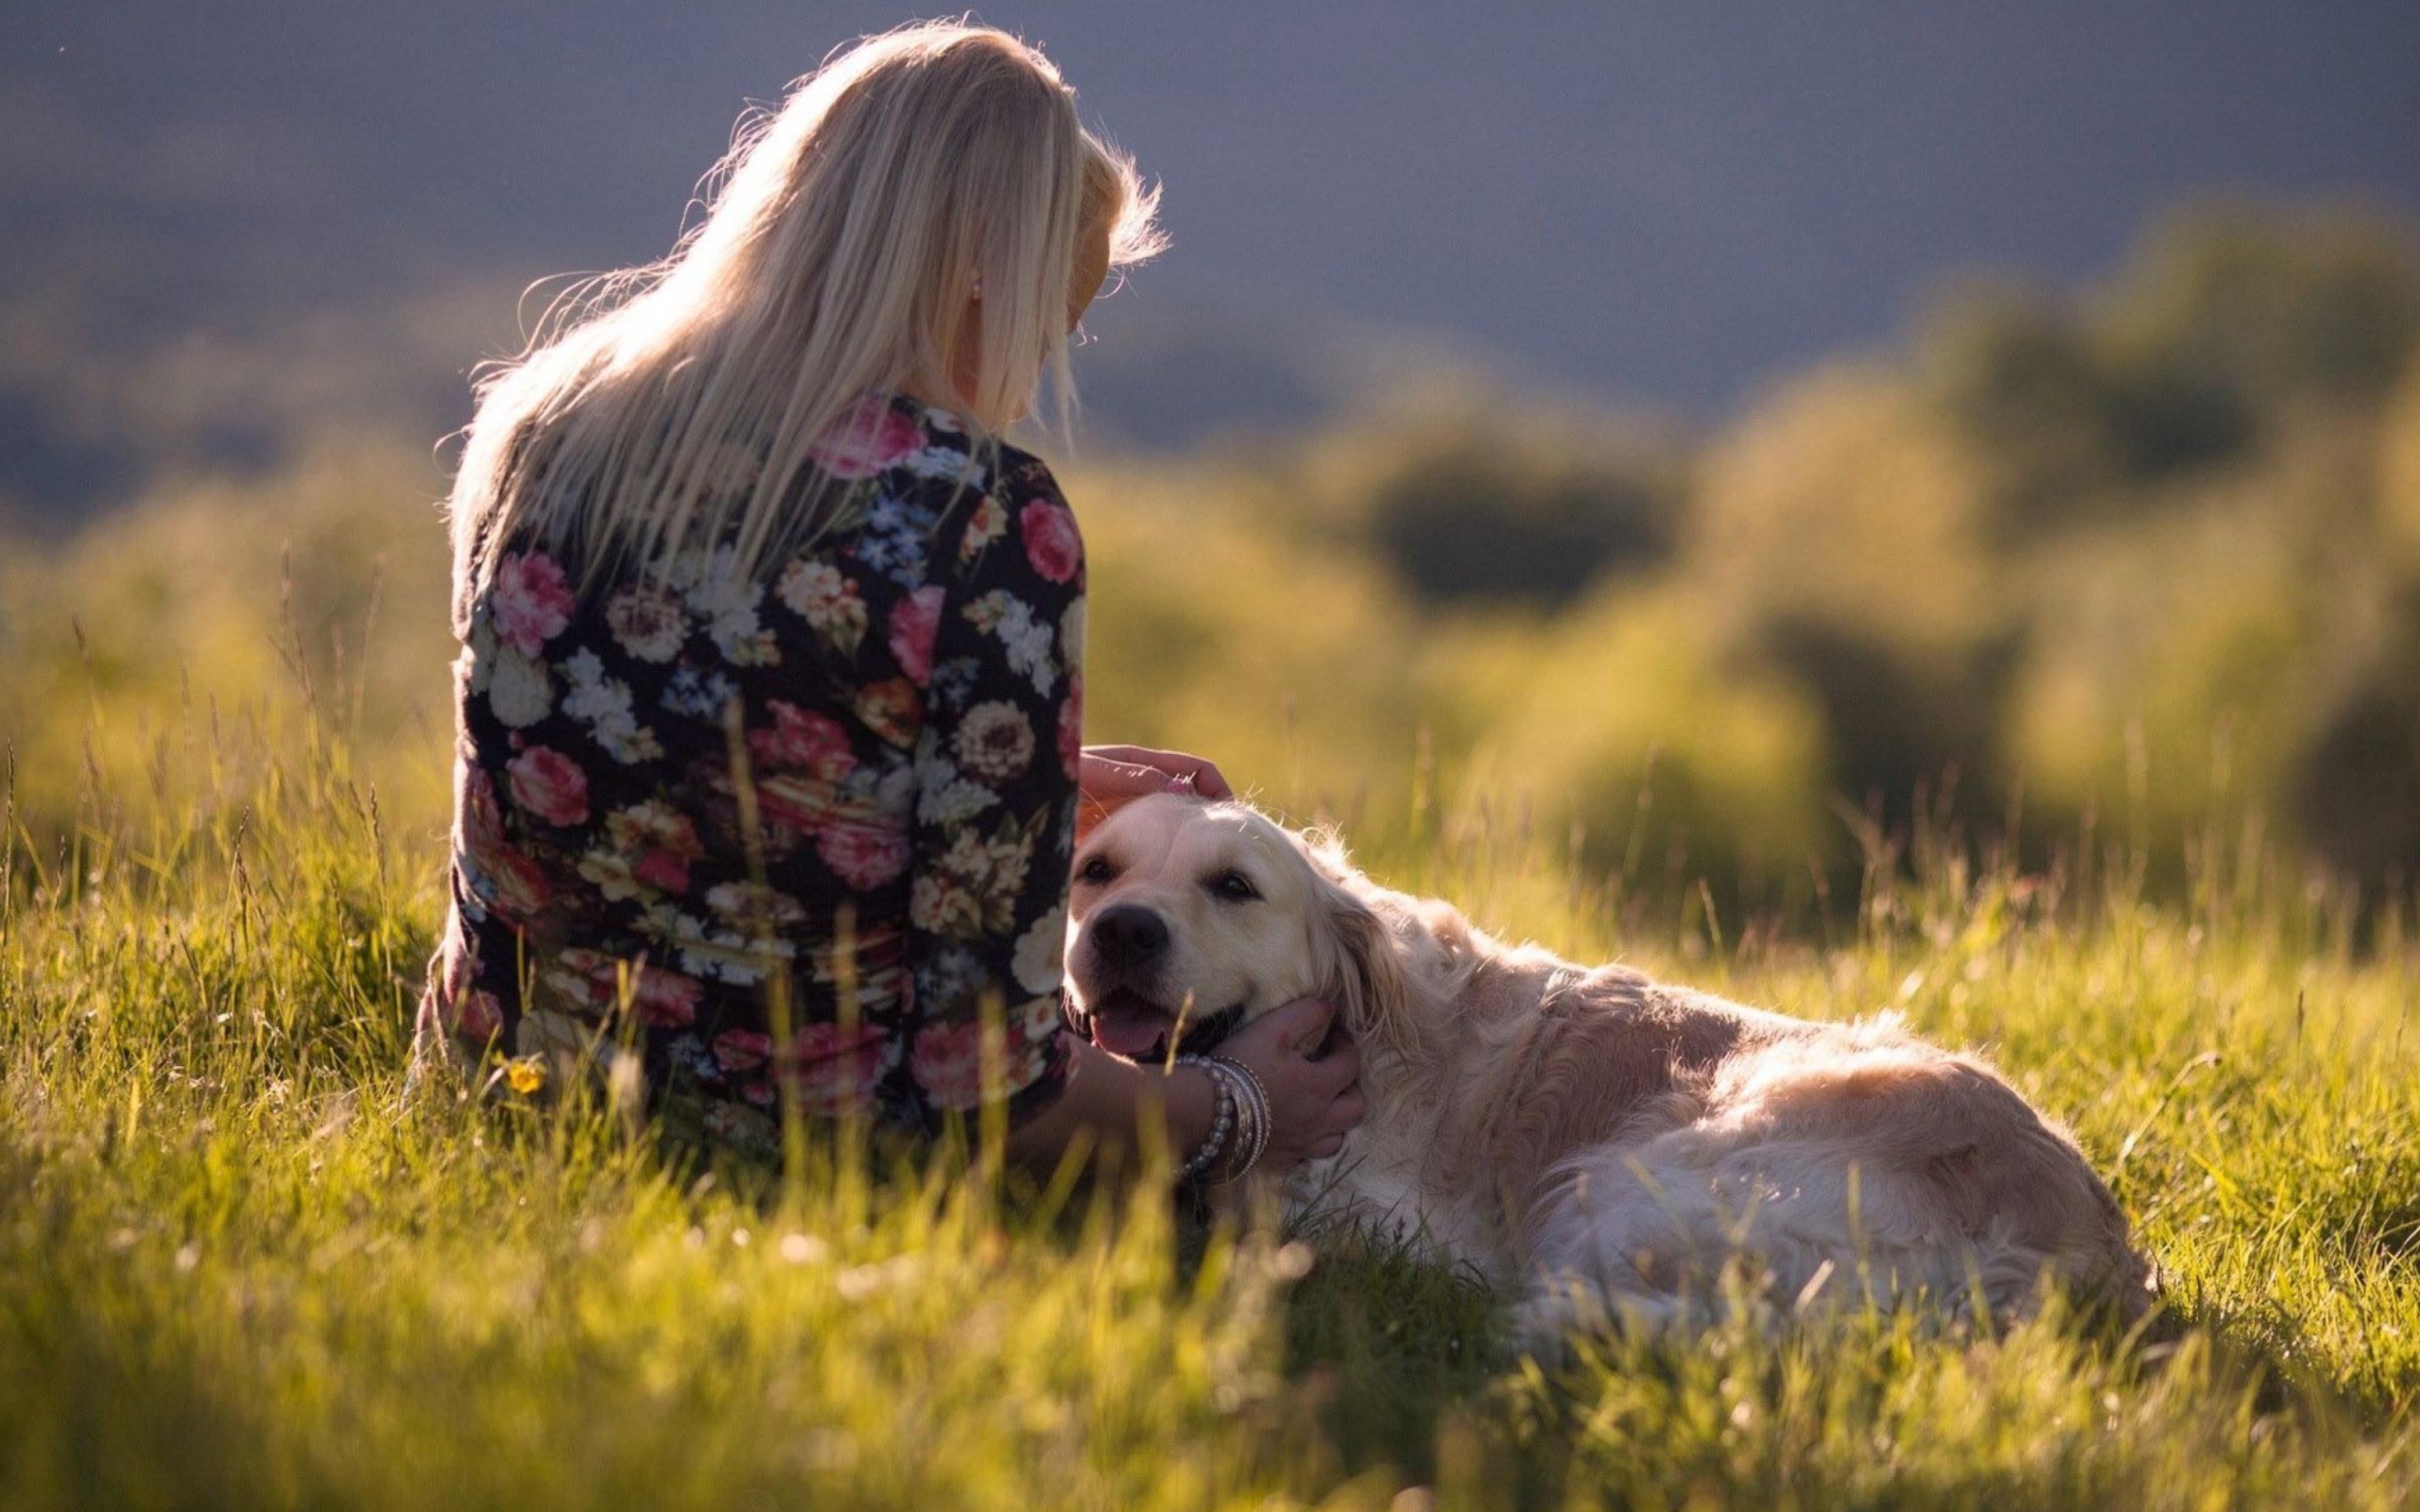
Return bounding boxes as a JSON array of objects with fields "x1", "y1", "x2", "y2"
[{"x1": 0, "y1": 711, "x2": 2420, "y2": 1509}]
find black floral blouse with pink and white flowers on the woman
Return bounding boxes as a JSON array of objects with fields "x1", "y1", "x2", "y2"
[{"x1": 421, "y1": 397, "x2": 1084, "y2": 1152}]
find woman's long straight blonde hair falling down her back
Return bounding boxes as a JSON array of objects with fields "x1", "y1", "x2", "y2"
[{"x1": 448, "y1": 22, "x2": 1164, "y2": 636}]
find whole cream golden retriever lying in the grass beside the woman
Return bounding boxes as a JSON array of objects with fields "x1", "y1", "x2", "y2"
[{"x1": 1067, "y1": 796, "x2": 2149, "y2": 1333}]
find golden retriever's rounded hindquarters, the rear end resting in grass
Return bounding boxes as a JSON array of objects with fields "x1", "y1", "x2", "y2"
[{"x1": 1530, "y1": 977, "x2": 2147, "y2": 1316}]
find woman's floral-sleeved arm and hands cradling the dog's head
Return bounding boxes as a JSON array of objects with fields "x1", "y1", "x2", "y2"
[{"x1": 908, "y1": 447, "x2": 1360, "y2": 1168}]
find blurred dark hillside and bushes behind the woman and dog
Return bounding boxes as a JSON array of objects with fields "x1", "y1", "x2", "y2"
[{"x1": 0, "y1": 0, "x2": 2420, "y2": 921}]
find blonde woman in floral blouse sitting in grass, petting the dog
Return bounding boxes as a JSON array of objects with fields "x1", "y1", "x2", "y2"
[{"x1": 421, "y1": 25, "x2": 1360, "y2": 1174}]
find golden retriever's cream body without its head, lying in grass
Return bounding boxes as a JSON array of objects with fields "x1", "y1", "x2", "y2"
[{"x1": 1331, "y1": 888, "x2": 2149, "y2": 1321}]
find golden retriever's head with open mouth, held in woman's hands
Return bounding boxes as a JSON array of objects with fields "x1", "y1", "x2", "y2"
[{"x1": 1067, "y1": 794, "x2": 1409, "y2": 1059}]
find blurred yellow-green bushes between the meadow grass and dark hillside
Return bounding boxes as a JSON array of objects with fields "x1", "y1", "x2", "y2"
[{"x1": 14, "y1": 206, "x2": 2420, "y2": 914}]
